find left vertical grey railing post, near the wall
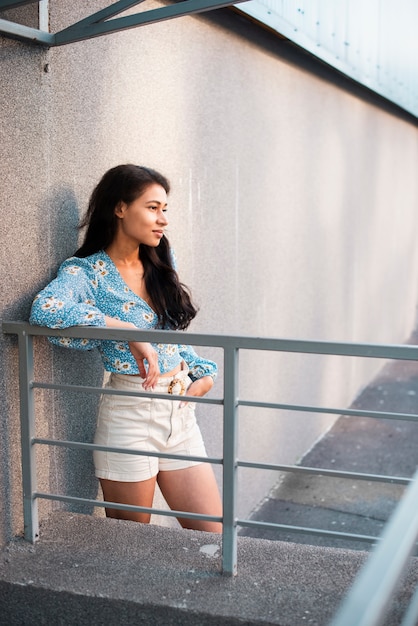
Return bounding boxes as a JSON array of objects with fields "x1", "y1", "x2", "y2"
[{"x1": 19, "y1": 331, "x2": 39, "y2": 543}]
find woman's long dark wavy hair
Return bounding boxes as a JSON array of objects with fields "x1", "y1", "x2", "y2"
[{"x1": 74, "y1": 164, "x2": 197, "y2": 330}]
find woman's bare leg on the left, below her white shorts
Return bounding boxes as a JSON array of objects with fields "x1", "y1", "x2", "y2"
[{"x1": 100, "y1": 476, "x2": 156, "y2": 524}]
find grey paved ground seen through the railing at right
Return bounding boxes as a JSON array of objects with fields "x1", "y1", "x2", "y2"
[{"x1": 240, "y1": 336, "x2": 418, "y2": 550}]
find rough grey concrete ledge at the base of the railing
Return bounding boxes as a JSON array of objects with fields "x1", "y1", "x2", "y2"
[{"x1": 0, "y1": 513, "x2": 418, "y2": 626}]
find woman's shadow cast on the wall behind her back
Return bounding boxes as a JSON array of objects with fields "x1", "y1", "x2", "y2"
[{"x1": 38, "y1": 187, "x2": 103, "y2": 513}]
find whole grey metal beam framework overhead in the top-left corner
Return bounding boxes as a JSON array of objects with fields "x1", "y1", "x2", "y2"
[{"x1": 0, "y1": 0, "x2": 248, "y2": 47}]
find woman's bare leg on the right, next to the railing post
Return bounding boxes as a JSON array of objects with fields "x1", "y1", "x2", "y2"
[{"x1": 158, "y1": 463, "x2": 222, "y2": 533}]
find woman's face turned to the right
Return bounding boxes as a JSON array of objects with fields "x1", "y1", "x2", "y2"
[{"x1": 115, "y1": 183, "x2": 168, "y2": 247}]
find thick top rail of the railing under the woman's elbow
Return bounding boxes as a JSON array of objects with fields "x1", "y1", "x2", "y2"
[{"x1": 2, "y1": 321, "x2": 418, "y2": 361}]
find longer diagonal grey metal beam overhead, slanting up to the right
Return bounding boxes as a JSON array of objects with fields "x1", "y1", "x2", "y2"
[{"x1": 54, "y1": 0, "x2": 247, "y2": 46}]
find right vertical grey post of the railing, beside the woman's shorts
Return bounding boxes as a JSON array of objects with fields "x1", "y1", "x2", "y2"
[{"x1": 222, "y1": 346, "x2": 238, "y2": 576}]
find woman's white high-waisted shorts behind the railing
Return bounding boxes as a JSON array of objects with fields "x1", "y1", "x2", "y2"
[{"x1": 93, "y1": 370, "x2": 207, "y2": 482}]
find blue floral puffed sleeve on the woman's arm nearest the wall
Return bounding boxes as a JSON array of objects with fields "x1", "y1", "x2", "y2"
[{"x1": 29, "y1": 257, "x2": 106, "y2": 350}]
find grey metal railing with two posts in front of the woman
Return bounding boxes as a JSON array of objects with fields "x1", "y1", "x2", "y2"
[{"x1": 3, "y1": 322, "x2": 418, "y2": 608}]
